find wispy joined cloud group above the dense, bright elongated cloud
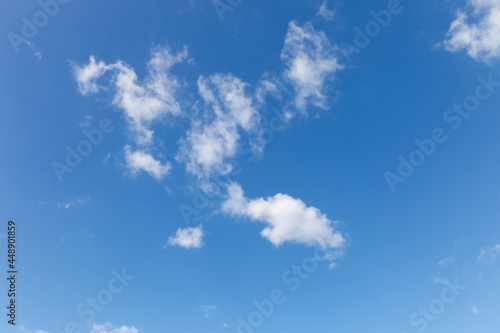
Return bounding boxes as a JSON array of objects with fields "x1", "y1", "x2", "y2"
[{"x1": 73, "y1": 20, "x2": 343, "y2": 183}]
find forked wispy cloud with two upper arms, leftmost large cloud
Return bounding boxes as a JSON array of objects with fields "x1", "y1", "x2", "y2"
[{"x1": 74, "y1": 47, "x2": 188, "y2": 144}]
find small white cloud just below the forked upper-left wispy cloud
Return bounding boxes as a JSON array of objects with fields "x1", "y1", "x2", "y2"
[{"x1": 125, "y1": 146, "x2": 172, "y2": 180}]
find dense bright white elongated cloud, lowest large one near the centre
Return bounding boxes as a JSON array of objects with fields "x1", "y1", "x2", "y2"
[{"x1": 222, "y1": 183, "x2": 344, "y2": 249}]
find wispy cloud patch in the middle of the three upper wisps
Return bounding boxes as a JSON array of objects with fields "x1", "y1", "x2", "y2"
[{"x1": 177, "y1": 74, "x2": 260, "y2": 177}]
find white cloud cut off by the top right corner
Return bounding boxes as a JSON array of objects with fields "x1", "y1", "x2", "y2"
[{"x1": 444, "y1": 0, "x2": 500, "y2": 61}]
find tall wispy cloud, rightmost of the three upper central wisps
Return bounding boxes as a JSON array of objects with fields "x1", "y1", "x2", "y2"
[{"x1": 281, "y1": 21, "x2": 344, "y2": 114}]
